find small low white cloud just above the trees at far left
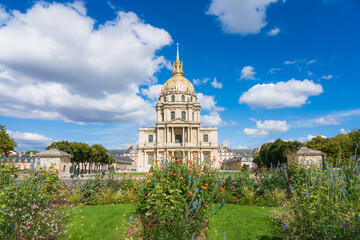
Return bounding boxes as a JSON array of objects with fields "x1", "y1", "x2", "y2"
[{"x1": 7, "y1": 130, "x2": 53, "y2": 151}]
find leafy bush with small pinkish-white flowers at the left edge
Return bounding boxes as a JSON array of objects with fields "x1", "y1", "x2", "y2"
[{"x1": 0, "y1": 155, "x2": 72, "y2": 239}]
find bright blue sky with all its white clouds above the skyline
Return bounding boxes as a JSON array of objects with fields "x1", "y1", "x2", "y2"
[{"x1": 0, "y1": 0, "x2": 360, "y2": 151}]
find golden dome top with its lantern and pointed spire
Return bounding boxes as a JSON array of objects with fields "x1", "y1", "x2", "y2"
[{"x1": 161, "y1": 45, "x2": 195, "y2": 93}]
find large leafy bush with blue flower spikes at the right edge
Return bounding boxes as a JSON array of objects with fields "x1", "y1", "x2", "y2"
[{"x1": 275, "y1": 158, "x2": 360, "y2": 239}]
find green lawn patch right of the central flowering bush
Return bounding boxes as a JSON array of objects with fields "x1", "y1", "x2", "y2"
[{"x1": 206, "y1": 204, "x2": 282, "y2": 240}]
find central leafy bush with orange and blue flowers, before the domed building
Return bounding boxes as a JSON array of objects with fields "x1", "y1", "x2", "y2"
[{"x1": 132, "y1": 155, "x2": 225, "y2": 239}]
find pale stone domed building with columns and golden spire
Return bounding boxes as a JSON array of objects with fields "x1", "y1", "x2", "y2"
[{"x1": 136, "y1": 47, "x2": 219, "y2": 171}]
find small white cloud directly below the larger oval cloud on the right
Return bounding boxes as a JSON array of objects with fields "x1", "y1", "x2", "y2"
[{"x1": 244, "y1": 120, "x2": 290, "y2": 137}]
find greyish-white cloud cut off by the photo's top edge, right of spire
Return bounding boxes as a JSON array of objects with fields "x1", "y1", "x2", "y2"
[{"x1": 207, "y1": 0, "x2": 278, "y2": 35}]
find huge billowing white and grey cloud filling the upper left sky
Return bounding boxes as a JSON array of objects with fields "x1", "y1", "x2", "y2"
[{"x1": 0, "y1": 1, "x2": 172, "y2": 123}]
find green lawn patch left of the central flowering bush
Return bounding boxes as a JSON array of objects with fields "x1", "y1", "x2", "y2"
[{"x1": 61, "y1": 204, "x2": 135, "y2": 240}]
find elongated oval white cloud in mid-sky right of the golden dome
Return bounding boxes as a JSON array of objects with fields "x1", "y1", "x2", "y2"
[{"x1": 239, "y1": 79, "x2": 323, "y2": 109}]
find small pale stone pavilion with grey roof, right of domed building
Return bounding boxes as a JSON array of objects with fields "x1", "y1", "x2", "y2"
[{"x1": 286, "y1": 147, "x2": 324, "y2": 167}]
